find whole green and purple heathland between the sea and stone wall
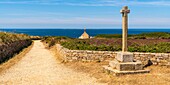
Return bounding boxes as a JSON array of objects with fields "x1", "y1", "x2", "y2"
[{"x1": 43, "y1": 33, "x2": 170, "y2": 53}]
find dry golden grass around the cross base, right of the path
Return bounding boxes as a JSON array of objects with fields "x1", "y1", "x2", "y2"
[{"x1": 50, "y1": 45, "x2": 170, "y2": 85}]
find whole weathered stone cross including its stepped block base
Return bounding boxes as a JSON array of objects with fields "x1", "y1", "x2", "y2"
[{"x1": 103, "y1": 6, "x2": 149, "y2": 75}]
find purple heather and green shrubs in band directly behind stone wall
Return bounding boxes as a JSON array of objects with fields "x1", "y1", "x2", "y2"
[{"x1": 61, "y1": 39, "x2": 170, "y2": 53}]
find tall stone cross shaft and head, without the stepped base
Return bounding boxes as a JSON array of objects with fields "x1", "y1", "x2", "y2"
[{"x1": 120, "y1": 6, "x2": 130, "y2": 52}]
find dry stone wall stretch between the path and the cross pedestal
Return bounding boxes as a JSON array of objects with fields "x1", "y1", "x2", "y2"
[{"x1": 56, "y1": 44, "x2": 116, "y2": 61}]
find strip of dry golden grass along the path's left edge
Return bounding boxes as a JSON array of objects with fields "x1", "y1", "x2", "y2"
[{"x1": 0, "y1": 42, "x2": 34, "y2": 73}]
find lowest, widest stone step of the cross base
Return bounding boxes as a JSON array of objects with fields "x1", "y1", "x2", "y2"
[{"x1": 103, "y1": 66, "x2": 150, "y2": 76}]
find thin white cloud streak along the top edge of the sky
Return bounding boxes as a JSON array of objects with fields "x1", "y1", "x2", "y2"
[{"x1": 0, "y1": 0, "x2": 170, "y2": 6}]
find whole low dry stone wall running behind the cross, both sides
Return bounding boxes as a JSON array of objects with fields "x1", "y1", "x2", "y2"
[{"x1": 56, "y1": 44, "x2": 170, "y2": 65}]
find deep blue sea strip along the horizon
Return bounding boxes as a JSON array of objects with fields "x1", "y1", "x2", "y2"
[{"x1": 0, "y1": 28, "x2": 170, "y2": 38}]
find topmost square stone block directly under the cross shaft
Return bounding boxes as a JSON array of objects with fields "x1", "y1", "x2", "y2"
[{"x1": 116, "y1": 52, "x2": 133, "y2": 62}]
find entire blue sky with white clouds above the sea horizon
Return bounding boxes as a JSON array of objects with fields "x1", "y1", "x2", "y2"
[{"x1": 0, "y1": 0, "x2": 170, "y2": 29}]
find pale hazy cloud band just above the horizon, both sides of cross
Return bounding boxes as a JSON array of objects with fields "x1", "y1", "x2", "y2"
[{"x1": 0, "y1": 17, "x2": 170, "y2": 28}]
